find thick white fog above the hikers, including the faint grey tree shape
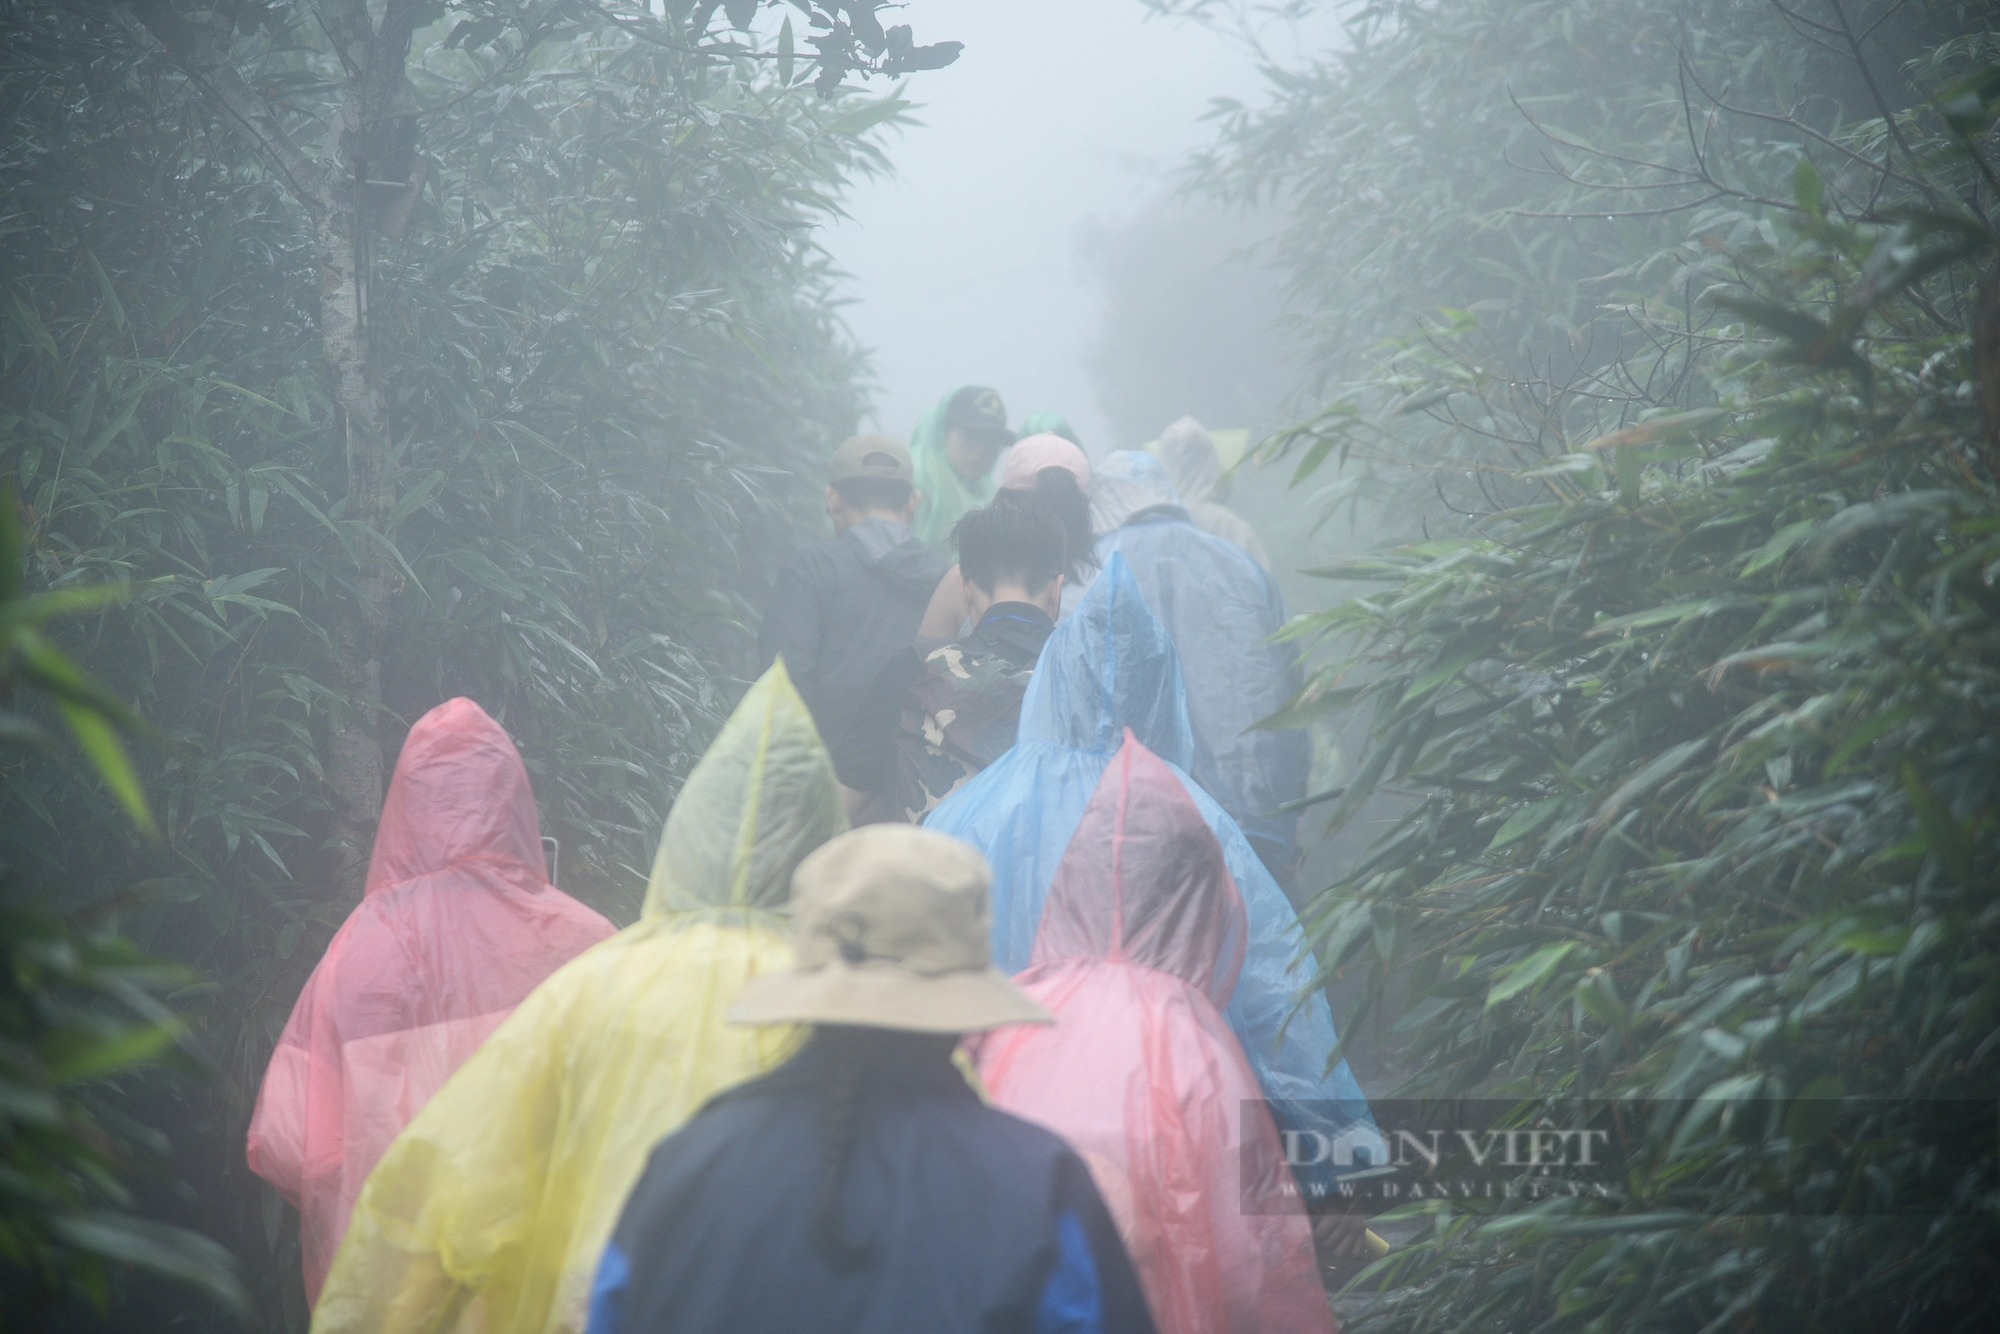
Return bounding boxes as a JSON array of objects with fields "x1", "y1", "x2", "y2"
[{"x1": 824, "y1": 0, "x2": 1336, "y2": 456}]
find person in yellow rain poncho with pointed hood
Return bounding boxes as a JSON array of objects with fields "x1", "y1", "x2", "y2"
[{"x1": 312, "y1": 664, "x2": 846, "y2": 1334}]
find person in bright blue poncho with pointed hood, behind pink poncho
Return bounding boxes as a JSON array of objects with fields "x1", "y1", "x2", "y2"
[{"x1": 924, "y1": 556, "x2": 1374, "y2": 1184}]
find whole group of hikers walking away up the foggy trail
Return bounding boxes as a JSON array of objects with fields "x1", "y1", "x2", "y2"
[{"x1": 248, "y1": 386, "x2": 1370, "y2": 1334}]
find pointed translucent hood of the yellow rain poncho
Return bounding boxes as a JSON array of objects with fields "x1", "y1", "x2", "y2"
[{"x1": 642, "y1": 662, "x2": 848, "y2": 918}]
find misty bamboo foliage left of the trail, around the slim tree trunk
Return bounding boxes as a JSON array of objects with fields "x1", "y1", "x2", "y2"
[{"x1": 0, "y1": 0, "x2": 908, "y2": 1326}]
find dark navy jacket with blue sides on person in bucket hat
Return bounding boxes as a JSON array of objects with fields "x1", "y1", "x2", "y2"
[{"x1": 590, "y1": 1038, "x2": 1154, "y2": 1334}]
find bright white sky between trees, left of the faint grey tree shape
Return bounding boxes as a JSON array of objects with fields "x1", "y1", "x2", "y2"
[{"x1": 824, "y1": 0, "x2": 1328, "y2": 454}]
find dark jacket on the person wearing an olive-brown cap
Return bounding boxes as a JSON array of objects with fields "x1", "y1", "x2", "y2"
[{"x1": 758, "y1": 518, "x2": 952, "y2": 788}]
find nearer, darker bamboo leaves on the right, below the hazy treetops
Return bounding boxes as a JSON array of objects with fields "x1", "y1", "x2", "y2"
[{"x1": 1232, "y1": 4, "x2": 2000, "y2": 1330}]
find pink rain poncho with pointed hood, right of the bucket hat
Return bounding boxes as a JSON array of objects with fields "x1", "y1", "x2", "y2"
[{"x1": 978, "y1": 732, "x2": 1334, "y2": 1334}]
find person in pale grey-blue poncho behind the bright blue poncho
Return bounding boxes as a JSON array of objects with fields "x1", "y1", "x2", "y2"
[{"x1": 1090, "y1": 450, "x2": 1312, "y2": 880}]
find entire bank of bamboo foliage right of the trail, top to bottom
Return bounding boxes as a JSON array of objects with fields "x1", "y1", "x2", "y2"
[{"x1": 1184, "y1": 0, "x2": 2000, "y2": 1330}]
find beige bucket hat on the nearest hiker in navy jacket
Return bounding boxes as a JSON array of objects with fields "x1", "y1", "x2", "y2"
[{"x1": 730, "y1": 824, "x2": 1050, "y2": 1032}]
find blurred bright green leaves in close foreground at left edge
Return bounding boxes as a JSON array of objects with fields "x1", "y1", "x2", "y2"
[{"x1": 0, "y1": 488, "x2": 250, "y2": 1322}]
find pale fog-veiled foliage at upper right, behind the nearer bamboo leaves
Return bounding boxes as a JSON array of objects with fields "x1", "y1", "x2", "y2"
[{"x1": 1154, "y1": 0, "x2": 1990, "y2": 530}]
